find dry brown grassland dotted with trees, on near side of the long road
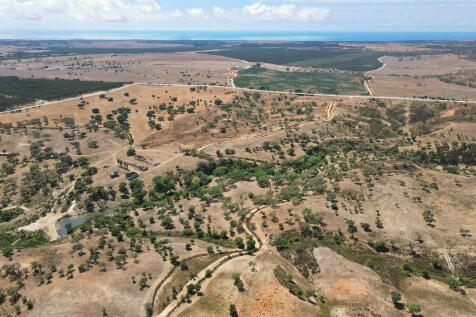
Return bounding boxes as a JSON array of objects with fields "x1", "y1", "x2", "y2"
[{"x1": 0, "y1": 56, "x2": 476, "y2": 316}]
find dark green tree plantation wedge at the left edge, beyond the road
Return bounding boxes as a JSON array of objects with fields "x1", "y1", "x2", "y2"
[{"x1": 0, "y1": 76, "x2": 123, "y2": 111}]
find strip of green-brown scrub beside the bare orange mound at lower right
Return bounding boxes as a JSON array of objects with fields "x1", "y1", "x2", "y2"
[{"x1": 273, "y1": 225, "x2": 476, "y2": 291}]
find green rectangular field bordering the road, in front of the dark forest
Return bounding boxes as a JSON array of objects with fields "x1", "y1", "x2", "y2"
[{"x1": 234, "y1": 67, "x2": 365, "y2": 94}]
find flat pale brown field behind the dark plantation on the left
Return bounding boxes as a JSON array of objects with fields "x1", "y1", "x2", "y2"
[{"x1": 0, "y1": 52, "x2": 249, "y2": 85}]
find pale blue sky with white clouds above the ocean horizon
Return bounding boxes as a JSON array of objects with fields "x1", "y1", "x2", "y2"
[{"x1": 0, "y1": 0, "x2": 476, "y2": 32}]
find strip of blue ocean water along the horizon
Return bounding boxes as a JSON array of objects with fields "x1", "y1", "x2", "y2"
[{"x1": 0, "y1": 29, "x2": 476, "y2": 42}]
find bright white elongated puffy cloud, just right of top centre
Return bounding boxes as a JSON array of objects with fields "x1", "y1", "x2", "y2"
[{"x1": 243, "y1": 2, "x2": 330, "y2": 22}]
